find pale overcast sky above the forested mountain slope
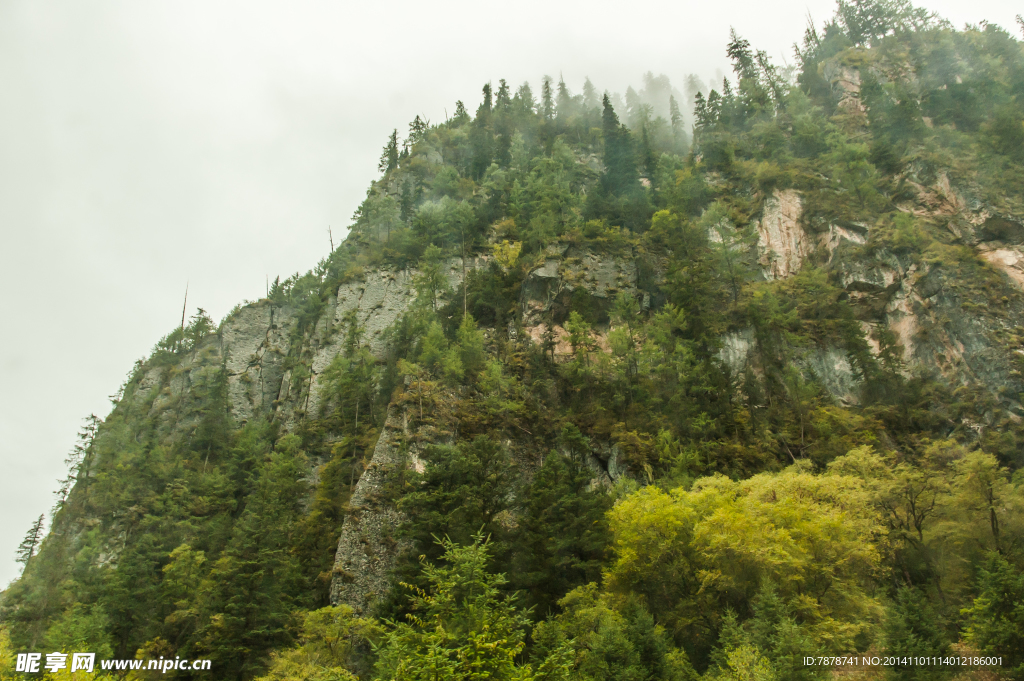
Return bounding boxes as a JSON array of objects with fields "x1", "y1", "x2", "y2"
[{"x1": 0, "y1": 0, "x2": 1020, "y2": 587}]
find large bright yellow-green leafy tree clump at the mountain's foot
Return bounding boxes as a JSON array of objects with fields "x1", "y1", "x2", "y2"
[{"x1": 607, "y1": 466, "x2": 886, "y2": 652}]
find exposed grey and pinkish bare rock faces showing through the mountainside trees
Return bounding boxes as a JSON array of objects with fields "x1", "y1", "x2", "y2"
[{"x1": 112, "y1": 173, "x2": 1024, "y2": 611}]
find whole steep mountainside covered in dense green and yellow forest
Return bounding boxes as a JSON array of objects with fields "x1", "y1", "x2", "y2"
[{"x1": 0, "y1": 0, "x2": 1024, "y2": 681}]
